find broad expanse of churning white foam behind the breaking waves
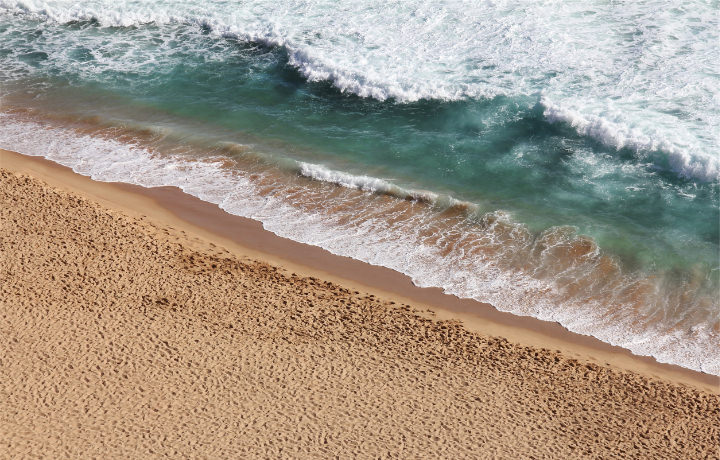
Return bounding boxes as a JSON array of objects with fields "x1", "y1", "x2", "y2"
[{"x1": 0, "y1": 0, "x2": 720, "y2": 181}]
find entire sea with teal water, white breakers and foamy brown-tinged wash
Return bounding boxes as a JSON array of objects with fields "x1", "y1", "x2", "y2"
[{"x1": 0, "y1": 0, "x2": 720, "y2": 375}]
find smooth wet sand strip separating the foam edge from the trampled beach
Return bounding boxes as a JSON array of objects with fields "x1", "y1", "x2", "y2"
[{"x1": 0, "y1": 150, "x2": 720, "y2": 394}]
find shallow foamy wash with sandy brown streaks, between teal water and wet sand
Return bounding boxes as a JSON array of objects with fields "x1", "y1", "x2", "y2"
[{"x1": 0, "y1": 113, "x2": 720, "y2": 375}]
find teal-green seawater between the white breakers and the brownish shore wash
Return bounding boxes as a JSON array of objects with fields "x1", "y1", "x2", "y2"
[{"x1": 0, "y1": 18, "x2": 720, "y2": 276}]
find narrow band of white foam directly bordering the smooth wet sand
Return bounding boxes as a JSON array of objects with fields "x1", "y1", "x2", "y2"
[{"x1": 0, "y1": 113, "x2": 720, "y2": 375}]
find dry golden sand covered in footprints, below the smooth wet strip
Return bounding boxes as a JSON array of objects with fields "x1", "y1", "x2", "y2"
[{"x1": 0, "y1": 150, "x2": 720, "y2": 459}]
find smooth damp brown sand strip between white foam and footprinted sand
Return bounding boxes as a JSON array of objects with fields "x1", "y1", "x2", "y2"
[{"x1": 0, "y1": 148, "x2": 720, "y2": 393}]
